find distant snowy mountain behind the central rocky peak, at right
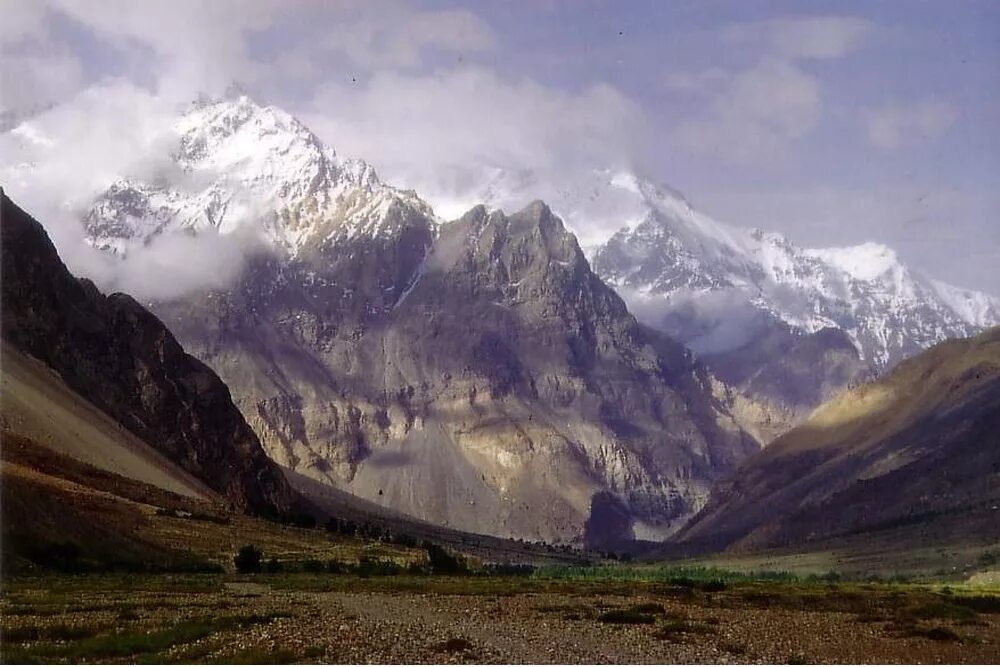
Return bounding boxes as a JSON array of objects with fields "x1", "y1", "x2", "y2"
[{"x1": 414, "y1": 166, "x2": 1000, "y2": 442}]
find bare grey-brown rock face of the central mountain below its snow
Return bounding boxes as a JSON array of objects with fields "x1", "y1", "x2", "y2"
[{"x1": 148, "y1": 203, "x2": 757, "y2": 541}]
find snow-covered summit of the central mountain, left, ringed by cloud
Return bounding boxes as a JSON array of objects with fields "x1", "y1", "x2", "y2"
[{"x1": 86, "y1": 94, "x2": 433, "y2": 256}]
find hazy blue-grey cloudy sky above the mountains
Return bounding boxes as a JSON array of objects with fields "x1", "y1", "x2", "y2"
[{"x1": 0, "y1": 0, "x2": 1000, "y2": 294}]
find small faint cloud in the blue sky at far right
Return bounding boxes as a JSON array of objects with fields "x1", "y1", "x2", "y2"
[{"x1": 861, "y1": 99, "x2": 958, "y2": 150}]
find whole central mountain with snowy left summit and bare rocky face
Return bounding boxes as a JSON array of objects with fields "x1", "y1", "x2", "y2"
[{"x1": 80, "y1": 96, "x2": 758, "y2": 541}]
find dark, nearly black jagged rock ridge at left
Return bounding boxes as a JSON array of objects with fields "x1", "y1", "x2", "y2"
[{"x1": 0, "y1": 195, "x2": 296, "y2": 515}]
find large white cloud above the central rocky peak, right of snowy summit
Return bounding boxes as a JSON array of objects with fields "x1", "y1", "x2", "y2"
[{"x1": 300, "y1": 66, "x2": 645, "y2": 216}]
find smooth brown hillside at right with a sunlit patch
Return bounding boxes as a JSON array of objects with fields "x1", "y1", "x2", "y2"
[{"x1": 676, "y1": 327, "x2": 1000, "y2": 549}]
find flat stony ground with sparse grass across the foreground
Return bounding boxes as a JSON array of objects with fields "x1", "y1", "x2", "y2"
[{"x1": 0, "y1": 575, "x2": 1000, "y2": 663}]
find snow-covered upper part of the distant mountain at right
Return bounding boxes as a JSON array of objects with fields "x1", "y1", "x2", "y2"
[{"x1": 593, "y1": 174, "x2": 1000, "y2": 368}]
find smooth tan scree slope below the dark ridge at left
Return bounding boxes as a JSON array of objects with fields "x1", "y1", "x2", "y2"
[{"x1": 0, "y1": 343, "x2": 215, "y2": 499}]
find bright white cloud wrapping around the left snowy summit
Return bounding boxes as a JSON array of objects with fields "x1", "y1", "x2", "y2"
[{"x1": 0, "y1": 81, "x2": 270, "y2": 300}]
